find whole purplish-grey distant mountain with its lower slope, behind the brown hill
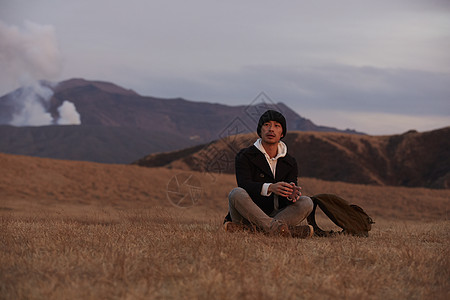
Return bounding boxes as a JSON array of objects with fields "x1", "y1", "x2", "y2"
[{"x1": 0, "y1": 79, "x2": 362, "y2": 163}]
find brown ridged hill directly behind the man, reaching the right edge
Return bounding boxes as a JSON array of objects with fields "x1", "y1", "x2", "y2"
[{"x1": 135, "y1": 127, "x2": 450, "y2": 189}]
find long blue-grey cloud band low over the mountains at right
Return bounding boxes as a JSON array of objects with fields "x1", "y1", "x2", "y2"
[{"x1": 127, "y1": 65, "x2": 450, "y2": 116}]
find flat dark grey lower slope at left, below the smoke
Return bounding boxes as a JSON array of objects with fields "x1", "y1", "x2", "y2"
[{"x1": 0, "y1": 125, "x2": 195, "y2": 164}]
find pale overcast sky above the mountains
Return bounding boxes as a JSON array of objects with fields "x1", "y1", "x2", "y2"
[{"x1": 0, "y1": 0, "x2": 450, "y2": 135}]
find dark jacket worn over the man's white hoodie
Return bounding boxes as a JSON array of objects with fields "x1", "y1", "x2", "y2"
[{"x1": 226, "y1": 145, "x2": 298, "y2": 221}]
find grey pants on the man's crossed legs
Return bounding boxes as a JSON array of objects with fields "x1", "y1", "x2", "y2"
[{"x1": 228, "y1": 187, "x2": 313, "y2": 232}]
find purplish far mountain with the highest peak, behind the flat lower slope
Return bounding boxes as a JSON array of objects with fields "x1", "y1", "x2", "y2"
[{"x1": 48, "y1": 79, "x2": 362, "y2": 138}]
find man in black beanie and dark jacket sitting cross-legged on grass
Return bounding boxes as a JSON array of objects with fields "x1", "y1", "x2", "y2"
[{"x1": 224, "y1": 110, "x2": 314, "y2": 238}]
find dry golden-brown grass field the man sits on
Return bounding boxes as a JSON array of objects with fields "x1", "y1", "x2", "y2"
[{"x1": 0, "y1": 154, "x2": 450, "y2": 299}]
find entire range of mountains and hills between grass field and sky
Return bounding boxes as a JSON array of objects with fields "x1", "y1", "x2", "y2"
[{"x1": 0, "y1": 79, "x2": 450, "y2": 188}]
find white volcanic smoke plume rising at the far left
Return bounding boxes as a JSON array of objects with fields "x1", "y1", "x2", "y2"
[{"x1": 0, "y1": 21, "x2": 80, "y2": 126}]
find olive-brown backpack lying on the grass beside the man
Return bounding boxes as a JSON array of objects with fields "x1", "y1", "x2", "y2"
[{"x1": 307, "y1": 194, "x2": 375, "y2": 237}]
